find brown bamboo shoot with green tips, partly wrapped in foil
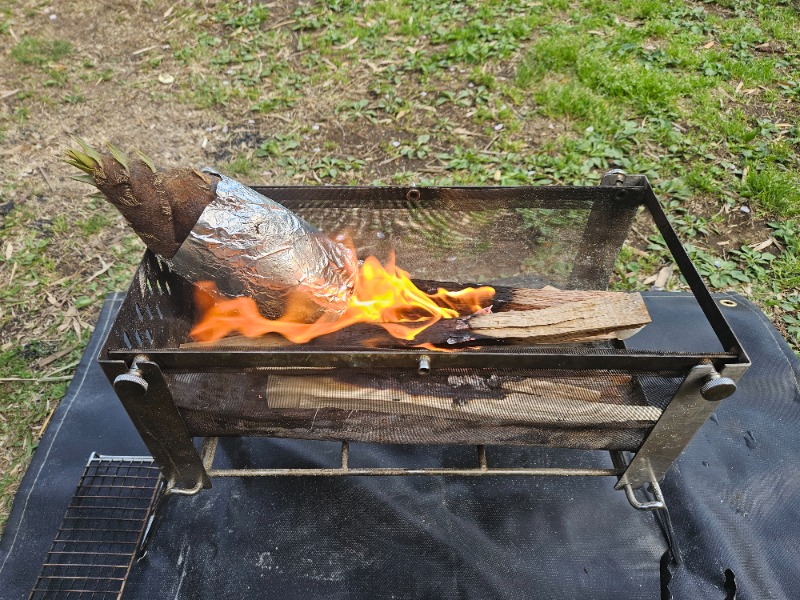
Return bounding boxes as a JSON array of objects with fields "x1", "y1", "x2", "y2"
[{"x1": 67, "y1": 139, "x2": 358, "y2": 322}]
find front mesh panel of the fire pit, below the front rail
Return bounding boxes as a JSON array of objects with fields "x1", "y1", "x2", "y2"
[{"x1": 167, "y1": 369, "x2": 678, "y2": 449}]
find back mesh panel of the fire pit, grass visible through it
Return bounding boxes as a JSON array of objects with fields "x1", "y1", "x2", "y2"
[{"x1": 259, "y1": 186, "x2": 636, "y2": 289}]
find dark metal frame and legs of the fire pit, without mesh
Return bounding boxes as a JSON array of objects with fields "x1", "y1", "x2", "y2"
[{"x1": 99, "y1": 172, "x2": 750, "y2": 498}]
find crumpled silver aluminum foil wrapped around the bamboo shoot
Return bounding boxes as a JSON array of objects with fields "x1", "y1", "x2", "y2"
[{"x1": 169, "y1": 169, "x2": 358, "y2": 321}]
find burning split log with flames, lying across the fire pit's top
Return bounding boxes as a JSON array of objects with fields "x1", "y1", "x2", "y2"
[{"x1": 184, "y1": 288, "x2": 650, "y2": 347}]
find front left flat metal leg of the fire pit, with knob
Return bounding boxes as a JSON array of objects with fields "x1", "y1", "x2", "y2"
[{"x1": 106, "y1": 356, "x2": 211, "y2": 494}]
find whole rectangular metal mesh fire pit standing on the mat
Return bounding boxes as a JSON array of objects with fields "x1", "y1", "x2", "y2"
[{"x1": 100, "y1": 172, "x2": 749, "y2": 508}]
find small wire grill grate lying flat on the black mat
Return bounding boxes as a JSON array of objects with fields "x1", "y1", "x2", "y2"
[{"x1": 29, "y1": 453, "x2": 160, "y2": 600}]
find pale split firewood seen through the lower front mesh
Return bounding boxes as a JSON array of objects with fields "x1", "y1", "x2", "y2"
[{"x1": 266, "y1": 369, "x2": 659, "y2": 414}]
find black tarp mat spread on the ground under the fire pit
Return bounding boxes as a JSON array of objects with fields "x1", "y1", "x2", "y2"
[{"x1": 0, "y1": 293, "x2": 800, "y2": 599}]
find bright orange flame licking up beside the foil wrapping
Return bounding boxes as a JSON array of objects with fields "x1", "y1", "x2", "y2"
[{"x1": 191, "y1": 254, "x2": 494, "y2": 344}]
